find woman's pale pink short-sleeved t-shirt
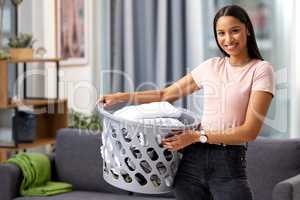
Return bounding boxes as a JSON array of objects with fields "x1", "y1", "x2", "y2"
[{"x1": 191, "y1": 57, "x2": 275, "y2": 130}]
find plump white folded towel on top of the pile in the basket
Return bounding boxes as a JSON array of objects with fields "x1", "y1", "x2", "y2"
[{"x1": 114, "y1": 101, "x2": 182, "y2": 121}]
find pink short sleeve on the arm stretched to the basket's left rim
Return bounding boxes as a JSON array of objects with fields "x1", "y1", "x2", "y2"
[{"x1": 191, "y1": 58, "x2": 213, "y2": 88}]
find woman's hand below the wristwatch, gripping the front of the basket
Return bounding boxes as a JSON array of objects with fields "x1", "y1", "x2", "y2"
[{"x1": 162, "y1": 130, "x2": 196, "y2": 151}]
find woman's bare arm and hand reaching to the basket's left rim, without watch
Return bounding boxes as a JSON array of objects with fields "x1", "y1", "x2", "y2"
[{"x1": 98, "y1": 74, "x2": 199, "y2": 105}]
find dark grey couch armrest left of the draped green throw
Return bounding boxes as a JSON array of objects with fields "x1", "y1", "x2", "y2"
[{"x1": 0, "y1": 163, "x2": 22, "y2": 200}]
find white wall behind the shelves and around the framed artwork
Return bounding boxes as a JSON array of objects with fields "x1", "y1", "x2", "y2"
[{"x1": 19, "y1": 0, "x2": 98, "y2": 113}]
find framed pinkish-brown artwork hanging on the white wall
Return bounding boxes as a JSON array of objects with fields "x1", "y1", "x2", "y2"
[{"x1": 55, "y1": 0, "x2": 88, "y2": 65}]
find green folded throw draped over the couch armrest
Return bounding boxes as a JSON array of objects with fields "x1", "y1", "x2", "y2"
[{"x1": 7, "y1": 153, "x2": 72, "y2": 196}]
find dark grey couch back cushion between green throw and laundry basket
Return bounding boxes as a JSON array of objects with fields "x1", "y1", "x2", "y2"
[{"x1": 55, "y1": 129, "x2": 128, "y2": 194}]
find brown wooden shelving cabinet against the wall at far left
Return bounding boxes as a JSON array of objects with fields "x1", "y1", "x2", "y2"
[{"x1": 0, "y1": 59, "x2": 68, "y2": 162}]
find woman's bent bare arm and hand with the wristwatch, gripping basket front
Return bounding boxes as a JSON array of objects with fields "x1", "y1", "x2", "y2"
[{"x1": 164, "y1": 91, "x2": 273, "y2": 150}]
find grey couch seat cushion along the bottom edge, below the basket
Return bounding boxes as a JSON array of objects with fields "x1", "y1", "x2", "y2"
[{"x1": 15, "y1": 191, "x2": 170, "y2": 200}]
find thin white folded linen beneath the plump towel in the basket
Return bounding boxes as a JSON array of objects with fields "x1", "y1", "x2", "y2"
[{"x1": 136, "y1": 117, "x2": 184, "y2": 127}]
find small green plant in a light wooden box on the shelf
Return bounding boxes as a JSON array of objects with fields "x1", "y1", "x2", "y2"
[{"x1": 8, "y1": 33, "x2": 35, "y2": 59}]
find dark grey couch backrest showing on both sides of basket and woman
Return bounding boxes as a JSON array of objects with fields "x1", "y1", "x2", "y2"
[{"x1": 55, "y1": 129, "x2": 300, "y2": 200}]
